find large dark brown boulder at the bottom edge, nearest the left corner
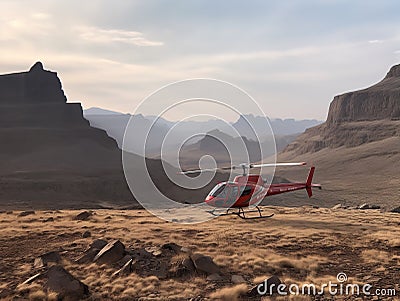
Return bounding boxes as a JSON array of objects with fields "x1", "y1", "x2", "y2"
[{"x1": 46, "y1": 265, "x2": 89, "y2": 300}]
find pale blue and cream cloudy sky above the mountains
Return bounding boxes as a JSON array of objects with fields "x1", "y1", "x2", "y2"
[{"x1": 0, "y1": 0, "x2": 400, "y2": 119}]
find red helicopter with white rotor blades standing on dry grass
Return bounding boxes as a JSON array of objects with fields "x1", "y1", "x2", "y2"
[{"x1": 182, "y1": 162, "x2": 321, "y2": 219}]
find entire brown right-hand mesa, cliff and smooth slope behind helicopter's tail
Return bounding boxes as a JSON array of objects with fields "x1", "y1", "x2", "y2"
[{"x1": 271, "y1": 65, "x2": 400, "y2": 209}]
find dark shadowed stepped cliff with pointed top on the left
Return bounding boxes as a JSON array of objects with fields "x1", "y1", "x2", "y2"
[{"x1": 0, "y1": 62, "x2": 136, "y2": 208}]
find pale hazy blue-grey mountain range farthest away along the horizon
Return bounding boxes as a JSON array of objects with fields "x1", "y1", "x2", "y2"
[{"x1": 84, "y1": 108, "x2": 320, "y2": 157}]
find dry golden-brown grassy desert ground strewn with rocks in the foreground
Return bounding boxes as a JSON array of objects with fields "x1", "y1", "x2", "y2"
[{"x1": 0, "y1": 206, "x2": 400, "y2": 301}]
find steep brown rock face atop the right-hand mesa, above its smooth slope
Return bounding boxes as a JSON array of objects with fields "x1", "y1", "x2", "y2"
[{"x1": 284, "y1": 65, "x2": 400, "y2": 154}]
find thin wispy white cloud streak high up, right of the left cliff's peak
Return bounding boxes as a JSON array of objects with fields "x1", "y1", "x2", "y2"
[{"x1": 75, "y1": 26, "x2": 164, "y2": 46}]
